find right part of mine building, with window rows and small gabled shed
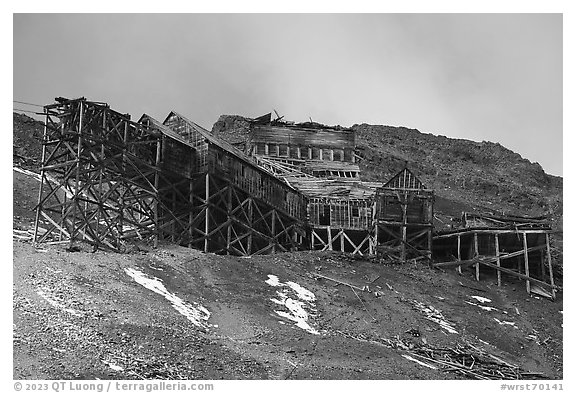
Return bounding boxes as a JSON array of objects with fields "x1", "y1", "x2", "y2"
[{"x1": 245, "y1": 116, "x2": 434, "y2": 261}]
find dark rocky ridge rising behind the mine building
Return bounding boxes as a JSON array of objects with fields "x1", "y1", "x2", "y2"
[{"x1": 212, "y1": 115, "x2": 562, "y2": 229}]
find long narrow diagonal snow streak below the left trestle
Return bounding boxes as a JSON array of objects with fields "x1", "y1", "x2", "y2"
[{"x1": 124, "y1": 268, "x2": 211, "y2": 329}]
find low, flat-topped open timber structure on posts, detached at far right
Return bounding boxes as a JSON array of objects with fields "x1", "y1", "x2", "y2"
[{"x1": 434, "y1": 212, "x2": 557, "y2": 299}]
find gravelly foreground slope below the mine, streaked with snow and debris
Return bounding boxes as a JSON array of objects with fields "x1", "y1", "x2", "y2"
[{"x1": 13, "y1": 112, "x2": 563, "y2": 380}]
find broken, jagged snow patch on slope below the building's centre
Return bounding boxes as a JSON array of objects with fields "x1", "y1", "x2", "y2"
[{"x1": 265, "y1": 274, "x2": 320, "y2": 334}]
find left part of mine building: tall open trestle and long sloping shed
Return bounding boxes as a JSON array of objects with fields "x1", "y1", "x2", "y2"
[{"x1": 35, "y1": 98, "x2": 306, "y2": 255}]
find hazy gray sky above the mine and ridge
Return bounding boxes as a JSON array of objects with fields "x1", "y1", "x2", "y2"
[{"x1": 14, "y1": 14, "x2": 562, "y2": 175}]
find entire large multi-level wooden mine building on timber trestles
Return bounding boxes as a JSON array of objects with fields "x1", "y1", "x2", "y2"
[{"x1": 35, "y1": 98, "x2": 433, "y2": 261}]
